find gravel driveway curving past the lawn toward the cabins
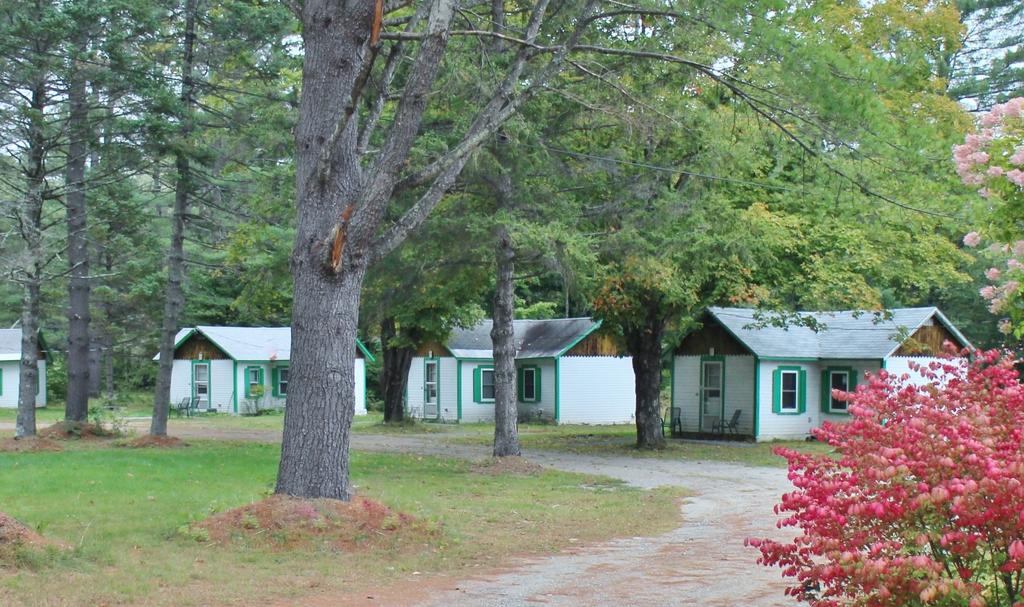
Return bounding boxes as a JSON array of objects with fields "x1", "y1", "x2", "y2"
[{"x1": 2, "y1": 422, "x2": 794, "y2": 607}]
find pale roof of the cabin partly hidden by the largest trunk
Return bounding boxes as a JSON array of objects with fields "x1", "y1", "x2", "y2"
[{"x1": 154, "y1": 326, "x2": 374, "y2": 361}]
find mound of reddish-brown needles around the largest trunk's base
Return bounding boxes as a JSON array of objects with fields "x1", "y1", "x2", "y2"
[{"x1": 183, "y1": 495, "x2": 440, "y2": 552}]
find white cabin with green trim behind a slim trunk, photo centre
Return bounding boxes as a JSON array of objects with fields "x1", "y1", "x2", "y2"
[{"x1": 406, "y1": 318, "x2": 636, "y2": 424}]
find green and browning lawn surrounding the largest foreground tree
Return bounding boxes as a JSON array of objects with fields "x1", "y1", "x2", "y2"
[{"x1": 0, "y1": 442, "x2": 681, "y2": 605}]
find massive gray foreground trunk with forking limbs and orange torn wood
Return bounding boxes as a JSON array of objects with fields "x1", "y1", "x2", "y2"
[{"x1": 276, "y1": 0, "x2": 569, "y2": 500}]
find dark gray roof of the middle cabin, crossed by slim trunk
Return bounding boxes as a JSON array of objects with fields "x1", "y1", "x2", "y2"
[{"x1": 446, "y1": 318, "x2": 601, "y2": 358}]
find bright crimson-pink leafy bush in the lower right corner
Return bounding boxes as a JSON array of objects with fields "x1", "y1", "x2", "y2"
[{"x1": 748, "y1": 350, "x2": 1024, "y2": 607}]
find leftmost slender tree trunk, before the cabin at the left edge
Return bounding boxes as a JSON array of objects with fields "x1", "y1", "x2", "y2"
[{"x1": 14, "y1": 78, "x2": 47, "y2": 438}]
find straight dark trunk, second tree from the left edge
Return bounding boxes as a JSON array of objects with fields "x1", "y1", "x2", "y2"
[{"x1": 65, "y1": 40, "x2": 90, "y2": 422}]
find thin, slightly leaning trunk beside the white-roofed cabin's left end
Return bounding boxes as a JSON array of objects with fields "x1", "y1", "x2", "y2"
[{"x1": 150, "y1": 0, "x2": 197, "y2": 436}]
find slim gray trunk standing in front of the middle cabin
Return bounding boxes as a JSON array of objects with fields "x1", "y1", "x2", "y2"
[{"x1": 490, "y1": 227, "x2": 521, "y2": 458}]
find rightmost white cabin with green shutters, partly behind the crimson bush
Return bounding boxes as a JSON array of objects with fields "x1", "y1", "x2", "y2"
[{"x1": 672, "y1": 307, "x2": 972, "y2": 441}]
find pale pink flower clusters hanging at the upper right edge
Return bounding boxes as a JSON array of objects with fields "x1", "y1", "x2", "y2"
[{"x1": 953, "y1": 97, "x2": 1024, "y2": 339}]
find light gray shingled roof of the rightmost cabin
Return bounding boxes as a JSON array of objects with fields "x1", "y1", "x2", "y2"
[{"x1": 708, "y1": 307, "x2": 971, "y2": 359}]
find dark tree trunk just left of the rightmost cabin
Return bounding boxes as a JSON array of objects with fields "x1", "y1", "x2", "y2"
[{"x1": 625, "y1": 319, "x2": 665, "y2": 449}]
